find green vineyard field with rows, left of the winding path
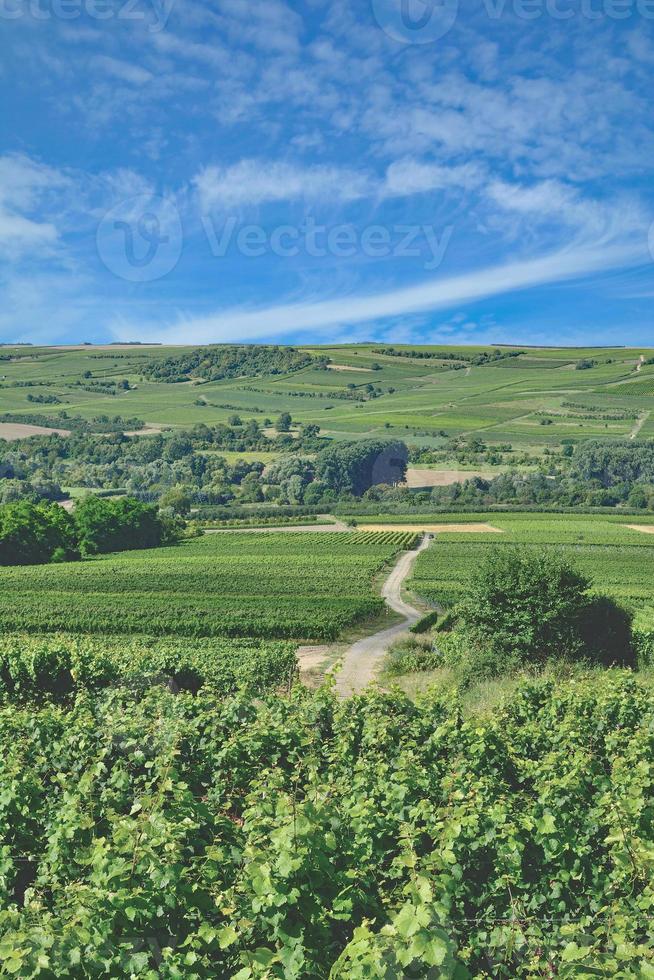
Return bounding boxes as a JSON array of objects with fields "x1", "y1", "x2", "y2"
[{"x1": 0, "y1": 532, "x2": 415, "y2": 639}]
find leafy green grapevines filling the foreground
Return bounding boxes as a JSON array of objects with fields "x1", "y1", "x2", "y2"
[{"x1": 0, "y1": 671, "x2": 654, "y2": 980}]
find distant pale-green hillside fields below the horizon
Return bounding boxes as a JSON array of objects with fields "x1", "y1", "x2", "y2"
[{"x1": 0, "y1": 344, "x2": 654, "y2": 450}]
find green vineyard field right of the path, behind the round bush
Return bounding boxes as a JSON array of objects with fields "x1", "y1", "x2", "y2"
[{"x1": 410, "y1": 514, "x2": 654, "y2": 628}]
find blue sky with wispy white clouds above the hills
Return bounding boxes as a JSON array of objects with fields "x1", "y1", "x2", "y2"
[{"x1": 0, "y1": 0, "x2": 654, "y2": 344}]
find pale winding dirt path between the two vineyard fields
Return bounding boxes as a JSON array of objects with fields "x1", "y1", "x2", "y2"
[{"x1": 336, "y1": 535, "x2": 431, "y2": 698}]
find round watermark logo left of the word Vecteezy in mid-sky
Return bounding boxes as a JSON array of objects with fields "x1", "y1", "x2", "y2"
[{"x1": 96, "y1": 194, "x2": 182, "y2": 282}]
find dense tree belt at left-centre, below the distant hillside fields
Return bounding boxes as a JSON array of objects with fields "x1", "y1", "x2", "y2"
[{"x1": 0, "y1": 424, "x2": 408, "y2": 513}]
